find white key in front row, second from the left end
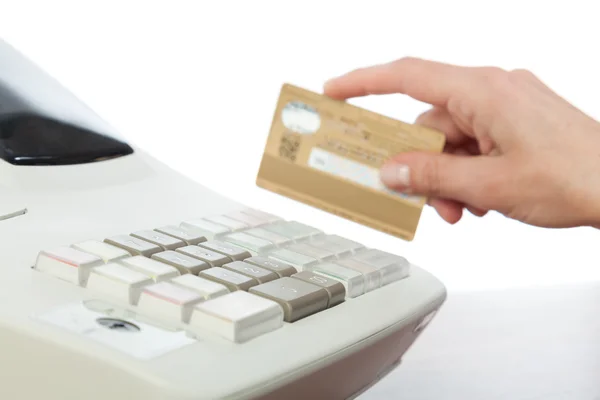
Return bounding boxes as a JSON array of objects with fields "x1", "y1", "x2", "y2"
[{"x1": 87, "y1": 263, "x2": 154, "y2": 305}]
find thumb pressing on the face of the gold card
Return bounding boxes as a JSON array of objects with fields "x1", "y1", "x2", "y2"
[{"x1": 380, "y1": 153, "x2": 505, "y2": 207}]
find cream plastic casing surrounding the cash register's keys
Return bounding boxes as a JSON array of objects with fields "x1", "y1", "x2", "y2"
[{"x1": 0, "y1": 39, "x2": 445, "y2": 400}]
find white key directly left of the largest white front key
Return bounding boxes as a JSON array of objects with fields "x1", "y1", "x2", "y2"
[{"x1": 138, "y1": 282, "x2": 204, "y2": 323}]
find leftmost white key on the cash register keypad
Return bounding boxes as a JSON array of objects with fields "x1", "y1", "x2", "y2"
[{"x1": 35, "y1": 246, "x2": 104, "y2": 287}]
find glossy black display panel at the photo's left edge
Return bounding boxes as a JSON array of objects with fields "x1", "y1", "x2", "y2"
[{"x1": 0, "y1": 113, "x2": 133, "y2": 165}]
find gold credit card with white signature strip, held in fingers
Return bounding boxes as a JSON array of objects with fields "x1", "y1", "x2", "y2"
[{"x1": 256, "y1": 84, "x2": 445, "y2": 240}]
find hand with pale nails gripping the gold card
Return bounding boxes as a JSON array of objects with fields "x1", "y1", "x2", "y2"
[{"x1": 325, "y1": 58, "x2": 600, "y2": 228}]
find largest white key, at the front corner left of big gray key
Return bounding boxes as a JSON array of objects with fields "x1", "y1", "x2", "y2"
[{"x1": 190, "y1": 291, "x2": 283, "y2": 343}]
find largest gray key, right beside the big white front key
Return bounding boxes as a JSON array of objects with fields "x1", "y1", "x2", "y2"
[{"x1": 249, "y1": 277, "x2": 329, "y2": 322}]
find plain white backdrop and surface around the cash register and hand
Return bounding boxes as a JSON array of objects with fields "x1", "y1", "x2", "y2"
[{"x1": 0, "y1": 0, "x2": 600, "y2": 399}]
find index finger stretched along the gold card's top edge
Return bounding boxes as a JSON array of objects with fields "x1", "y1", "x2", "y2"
[{"x1": 324, "y1": 58, "x2": 472, "y2": 106}]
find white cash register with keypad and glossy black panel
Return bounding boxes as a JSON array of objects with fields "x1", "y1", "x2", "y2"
[{"x1": 0, "y1": 41, "x2": 446, "y2": 400}]
